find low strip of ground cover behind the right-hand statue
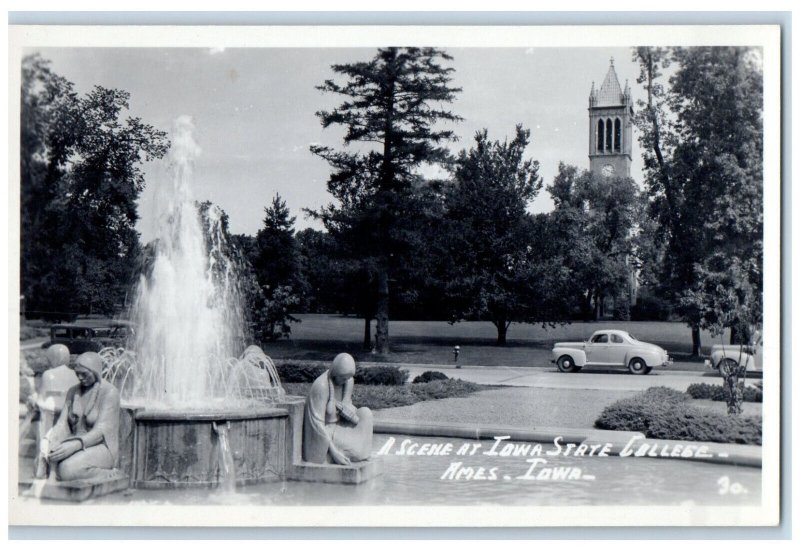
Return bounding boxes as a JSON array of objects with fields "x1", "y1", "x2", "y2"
[{"x1": 283, "y1": 379, "x2": 490, "y2": 410}]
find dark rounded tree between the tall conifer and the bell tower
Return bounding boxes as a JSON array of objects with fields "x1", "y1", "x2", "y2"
[{"x1": 438, "y1": 125, "x2": 560, "y2": 345}]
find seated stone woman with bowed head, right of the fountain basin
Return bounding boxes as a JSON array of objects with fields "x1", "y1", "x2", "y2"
[{"x1": 303, "y1": 354, "x2": 372, "y2": 465}]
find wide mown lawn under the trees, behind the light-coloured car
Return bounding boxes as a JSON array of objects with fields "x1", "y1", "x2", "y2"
[{"x1": 264, "y1": 314, "x2": 727, "y2": 370}]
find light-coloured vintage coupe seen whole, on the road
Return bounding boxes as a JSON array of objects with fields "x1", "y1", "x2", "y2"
[{"x1": 550, "y1": 329, "x2": 672, "y2": 375}]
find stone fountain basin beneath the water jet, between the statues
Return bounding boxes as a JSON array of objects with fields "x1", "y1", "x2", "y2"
[{"x1": 120, "y1": 396, "x2": 304, "y2": 489}]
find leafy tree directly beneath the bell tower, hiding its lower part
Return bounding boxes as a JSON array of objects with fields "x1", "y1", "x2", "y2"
[{"x1": 547, "y1": 163, "x2": 641, "y2": 319}]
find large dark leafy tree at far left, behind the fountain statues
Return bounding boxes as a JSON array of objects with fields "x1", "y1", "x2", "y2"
[{"x1": 20, "y1": 55, "x2": 169, "y2": 317}]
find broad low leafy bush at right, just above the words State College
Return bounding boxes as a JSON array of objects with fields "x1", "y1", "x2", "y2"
[{"x1": 595, "y1": 387, "x2": 761, "y2": 445}]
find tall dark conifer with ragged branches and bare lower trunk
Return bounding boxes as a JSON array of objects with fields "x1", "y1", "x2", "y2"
[{"x1": 311, "y1": 48, "x2": 460, "y2": 354}]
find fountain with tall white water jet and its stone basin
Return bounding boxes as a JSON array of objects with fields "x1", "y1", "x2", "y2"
[{"x1": 101, "y1": 117, "x2": 303, "y2": 488}]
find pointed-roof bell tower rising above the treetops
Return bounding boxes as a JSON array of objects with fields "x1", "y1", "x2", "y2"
[{"x1": 589, "y1": 57, "x2": 633, "y2": 178}]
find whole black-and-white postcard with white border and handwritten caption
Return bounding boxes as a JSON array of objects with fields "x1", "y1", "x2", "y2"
[{"x1": 8, "y1": 25, "x2": 788, "y2": 527}]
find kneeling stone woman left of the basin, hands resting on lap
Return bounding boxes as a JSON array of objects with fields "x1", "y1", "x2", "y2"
[{"x1": 40, "y1": 352, "x2": 120, "y2": 481}]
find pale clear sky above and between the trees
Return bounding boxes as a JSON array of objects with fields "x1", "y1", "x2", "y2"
[{"x1": 36, "y1": 44, "x2": 643, "y2": 242}]
